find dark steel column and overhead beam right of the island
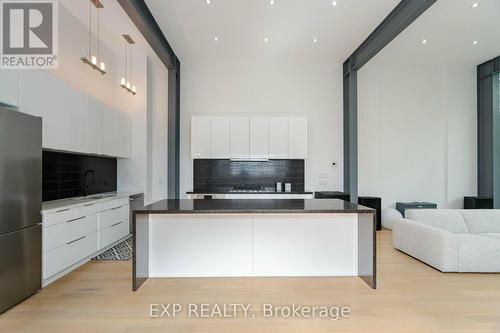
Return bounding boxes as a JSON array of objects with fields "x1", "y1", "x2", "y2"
[{"x1": 344, "y1": 0, "x2": 437, "y2": 203}]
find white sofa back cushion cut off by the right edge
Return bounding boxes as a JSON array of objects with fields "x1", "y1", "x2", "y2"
[{"x1": 462, "y1": 209, "x2": 500, "y2": 234}]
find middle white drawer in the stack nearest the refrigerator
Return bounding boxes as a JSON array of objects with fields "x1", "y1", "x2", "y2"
[{"x1": 43, "y1": 214, "x2": 98, "y2": 251}]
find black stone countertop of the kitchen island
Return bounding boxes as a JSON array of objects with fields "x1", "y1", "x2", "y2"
[{"x1": 134, "y1": 199, "x2": 375, "y2": 214}]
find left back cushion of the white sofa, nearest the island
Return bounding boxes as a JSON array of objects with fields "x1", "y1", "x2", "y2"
[{"x1": 405, "y1": 209, "x2": 469, "y2": 234}]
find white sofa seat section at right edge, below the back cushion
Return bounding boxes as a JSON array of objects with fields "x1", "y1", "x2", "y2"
[{"x1": 455, "y1": 234, "x2": 500, "y2": 273}]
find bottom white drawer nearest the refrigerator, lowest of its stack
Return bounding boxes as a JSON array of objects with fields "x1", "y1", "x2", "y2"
[{"x1": 43, "y1": 228, "x2": 99, "y2": 279}]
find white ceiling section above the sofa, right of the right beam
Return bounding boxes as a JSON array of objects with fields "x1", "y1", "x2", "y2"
[{"x1": 377, "y1": 0, "x2": 500, "y2": 66}]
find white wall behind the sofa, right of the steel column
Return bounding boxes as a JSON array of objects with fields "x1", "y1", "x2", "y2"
[{"x1": 358, "y1": 56, "x2": 477, "y2": 208}]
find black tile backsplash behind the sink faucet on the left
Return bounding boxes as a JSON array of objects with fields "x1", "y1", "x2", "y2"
[{"x1": 42, "y1": 151, "x2": 116, "y2": 201}]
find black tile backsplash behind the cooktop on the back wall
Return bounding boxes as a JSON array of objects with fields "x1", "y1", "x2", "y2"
[{"x1": 193, "y1": 159, "x2": 304, "y2": 192}]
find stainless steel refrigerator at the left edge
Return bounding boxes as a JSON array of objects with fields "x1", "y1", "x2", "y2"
[{"x1": 0, "y1": 106, "x2": 42, "y2": 313}]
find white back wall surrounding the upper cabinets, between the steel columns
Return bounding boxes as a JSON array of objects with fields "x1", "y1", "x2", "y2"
[{"x1": 180, "y1": 63, "x2": 343, "y2": 197}]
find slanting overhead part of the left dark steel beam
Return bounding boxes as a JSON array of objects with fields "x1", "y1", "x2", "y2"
[{"x1": 117, "y1": 0, "x2": 179, "y2": 70}]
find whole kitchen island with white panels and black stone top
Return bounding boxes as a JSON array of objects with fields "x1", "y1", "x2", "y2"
[{"x1": 132, "y1": 199, "x2": 376, "y2": 291}]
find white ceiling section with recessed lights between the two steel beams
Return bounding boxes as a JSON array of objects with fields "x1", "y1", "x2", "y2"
[{"x1": 146, "y1": 0, "x2": 398, "y2": 63}]
